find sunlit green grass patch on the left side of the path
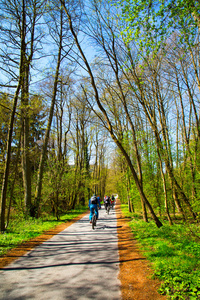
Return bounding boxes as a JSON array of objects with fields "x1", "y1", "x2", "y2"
[{"x1": 0, "y1": 207, "x2": 87, "y2": 255}]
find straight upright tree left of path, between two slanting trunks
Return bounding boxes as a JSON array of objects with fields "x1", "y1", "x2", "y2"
[{"x1": 1, "y1": 0, "x2": 45, "y2": 220}]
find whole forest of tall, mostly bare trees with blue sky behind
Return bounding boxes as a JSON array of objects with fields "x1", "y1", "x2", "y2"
[{"x1": 0, "y1": 0, "x2": 200, "y2": 232}]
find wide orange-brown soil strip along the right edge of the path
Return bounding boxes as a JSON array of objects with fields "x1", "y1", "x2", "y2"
[{"x1": 115, "y1": 202, "x2": 167, "y2": 300}]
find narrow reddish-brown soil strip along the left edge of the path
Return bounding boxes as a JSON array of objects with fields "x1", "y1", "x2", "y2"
[{"x1": 0, "y1": 212, "x2": 88, "y2": 269}]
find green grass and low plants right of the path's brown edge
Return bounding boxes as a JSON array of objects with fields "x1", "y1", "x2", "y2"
[{"x1": 121, "y1": 204, "x2": 200, "y2": 300}]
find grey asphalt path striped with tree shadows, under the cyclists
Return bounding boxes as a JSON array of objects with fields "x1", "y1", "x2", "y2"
[{"x1": 0, "y1": 208, "x2": 120, "y2": 300}]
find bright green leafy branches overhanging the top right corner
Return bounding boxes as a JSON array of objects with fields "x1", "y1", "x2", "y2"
[{"x1": 114, "y1": 0, "x2": 200, "y2": 55}]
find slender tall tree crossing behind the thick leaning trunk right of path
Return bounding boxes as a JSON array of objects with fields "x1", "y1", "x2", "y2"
[{"x1": 84, "y1": 2, "x2": 147, "y2": 221}]
